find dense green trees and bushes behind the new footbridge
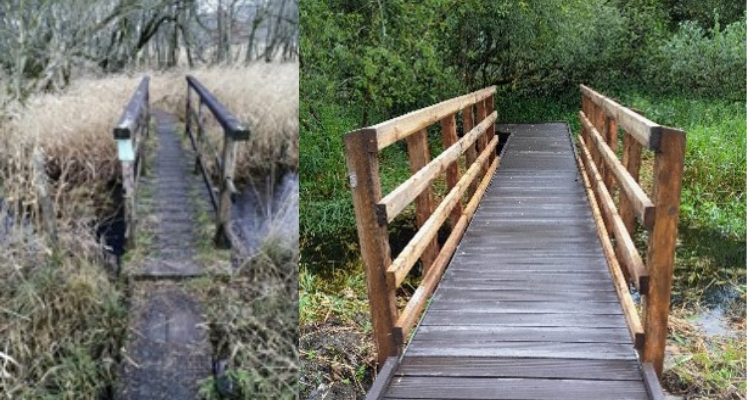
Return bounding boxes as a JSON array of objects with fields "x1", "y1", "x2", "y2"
[{"x1": 300, "y1": 0, "x2": 746, "y2": 250}]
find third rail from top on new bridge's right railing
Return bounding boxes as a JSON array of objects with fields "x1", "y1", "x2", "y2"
[{"x1": 579, "y1": 136, "x2": 649, "y2": 294}]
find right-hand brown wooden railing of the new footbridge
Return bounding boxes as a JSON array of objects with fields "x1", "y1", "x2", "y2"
[{"x1": 578, "y1": 85, "x2": 685, "y2": 377}]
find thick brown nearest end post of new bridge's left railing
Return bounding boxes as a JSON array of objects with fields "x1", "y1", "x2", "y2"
[{"x1": 345, "y1": 130, "x2": 401, "y2": 365}]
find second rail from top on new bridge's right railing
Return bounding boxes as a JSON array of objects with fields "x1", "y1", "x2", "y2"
[{"x1": 579, "y1": 112, "x2": 656, "y2": 227}]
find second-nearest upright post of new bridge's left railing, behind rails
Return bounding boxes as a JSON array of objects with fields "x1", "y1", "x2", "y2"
[{"x1": 405, "y1": 129, "x2": 439, "y2": 275}]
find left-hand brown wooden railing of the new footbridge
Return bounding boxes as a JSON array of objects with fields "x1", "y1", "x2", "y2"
[{"x1": 345, "y1": 87, "x2": 499, "y2": 365}]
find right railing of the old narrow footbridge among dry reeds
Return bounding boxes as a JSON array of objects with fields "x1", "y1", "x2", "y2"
[{"x1": 185, "y1": 76, "x2": 249, "y2": 248}]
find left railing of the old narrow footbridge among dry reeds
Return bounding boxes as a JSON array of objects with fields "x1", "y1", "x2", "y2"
[{"x1": 114, "y1": 76, "x2": 150, "y2": 247}]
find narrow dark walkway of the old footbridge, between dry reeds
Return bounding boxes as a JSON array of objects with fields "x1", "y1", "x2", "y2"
[{"x1": 116, "y1": 111, "x2": 211, "y2": 400}]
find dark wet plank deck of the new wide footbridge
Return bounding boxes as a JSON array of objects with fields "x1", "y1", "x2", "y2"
[{"x1": 370, "y1": 123, "x2": 650, "y2": 400}]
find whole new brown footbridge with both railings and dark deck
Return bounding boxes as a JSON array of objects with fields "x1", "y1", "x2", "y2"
[{"x1": 345, "y1": 85, "x2": 685, "y2": 400}]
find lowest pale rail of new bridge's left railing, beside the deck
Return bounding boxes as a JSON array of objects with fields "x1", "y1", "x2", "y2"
[{"x1": 395, "y1": 157, "x2": 501, "y2": 338}]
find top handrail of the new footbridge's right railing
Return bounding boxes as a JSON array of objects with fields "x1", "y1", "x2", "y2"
[{"x1": 580, "y1": 85, "x2": 662, "y2": 150}]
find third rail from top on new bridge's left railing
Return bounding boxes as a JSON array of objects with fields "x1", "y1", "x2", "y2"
[{"x1": 387, "y1": 139, "x2": 498, "y2": 287}]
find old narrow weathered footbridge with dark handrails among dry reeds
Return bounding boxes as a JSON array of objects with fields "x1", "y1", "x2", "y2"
[{"x1": 113, "y1": 77, "x2": 249, "y2": 400}]
